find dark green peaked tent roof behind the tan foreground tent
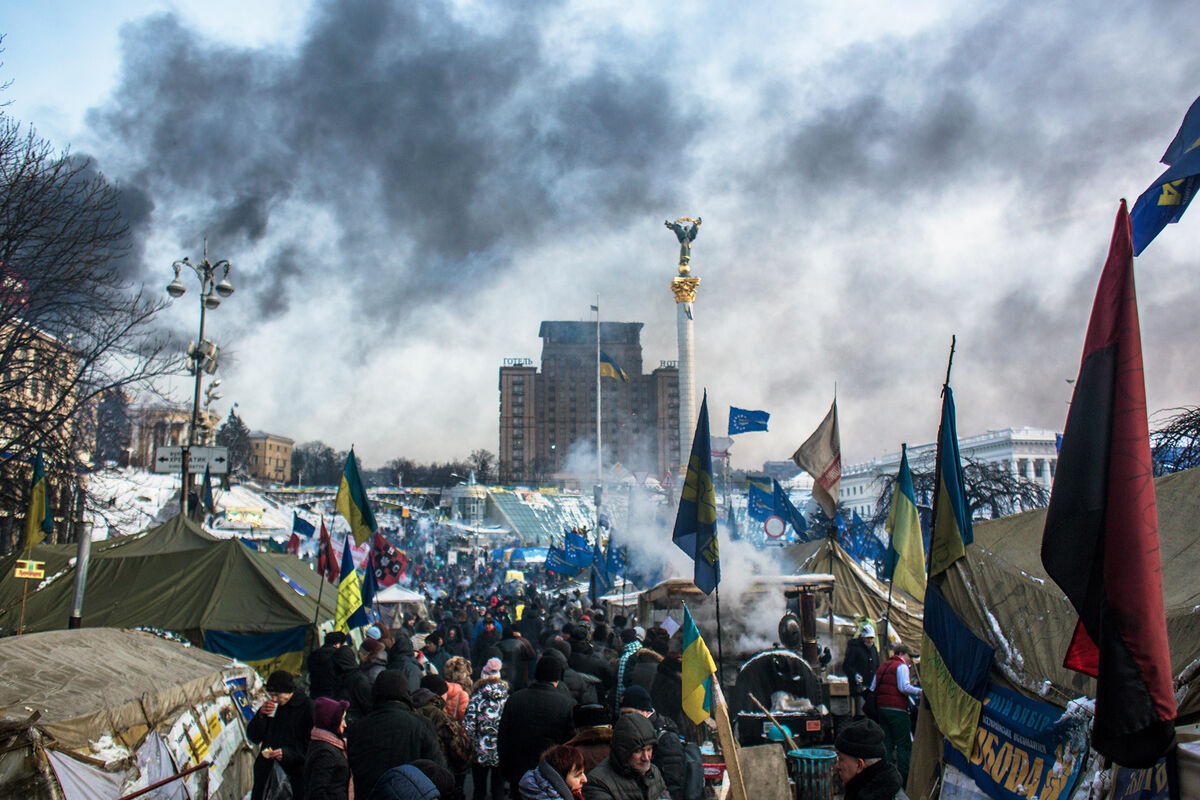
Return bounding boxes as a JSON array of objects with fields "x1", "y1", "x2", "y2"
[{"x1": 0, "y1": 517, "x2": 336, "y2": 643}]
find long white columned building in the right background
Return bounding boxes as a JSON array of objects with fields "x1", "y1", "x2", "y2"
[{"x1": 840, "y1": 428, "x2": 1058, "y2": 517}]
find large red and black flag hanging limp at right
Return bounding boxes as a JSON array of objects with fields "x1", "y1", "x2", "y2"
[{"x1": 1042, "y1": 200, "x2": 1176, "y2": 768}]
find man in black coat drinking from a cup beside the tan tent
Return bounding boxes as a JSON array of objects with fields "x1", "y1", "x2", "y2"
[{"x1": 246, "y1": 669, "x2": 312, "y2": 800}]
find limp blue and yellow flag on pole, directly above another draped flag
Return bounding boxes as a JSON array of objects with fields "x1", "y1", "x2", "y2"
[{"x1": 929, "y1": 385, "x2": 974, "y2": 577}]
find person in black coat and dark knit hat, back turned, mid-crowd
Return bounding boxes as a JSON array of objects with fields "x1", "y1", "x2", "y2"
[{"x1": 497, "y1": 656, "x2": 575, "y2": 786}]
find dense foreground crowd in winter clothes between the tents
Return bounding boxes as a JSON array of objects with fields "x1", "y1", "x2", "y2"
[{"x1": 247, "y1": 591, "x2": 697, "y2": 800}]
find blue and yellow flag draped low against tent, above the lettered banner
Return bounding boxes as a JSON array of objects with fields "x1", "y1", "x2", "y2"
[{"x1": 920, "y1": 581, "x2": 996, "y2": 758}]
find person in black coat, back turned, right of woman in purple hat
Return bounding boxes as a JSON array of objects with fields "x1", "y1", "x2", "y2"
[{"x1": 346, "y1": 669, "x2": 445, "y2": 798}]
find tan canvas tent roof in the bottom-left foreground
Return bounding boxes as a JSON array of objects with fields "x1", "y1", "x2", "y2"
[{"x1": 0, "y1": 628, "x2": 256, "y2": 748}]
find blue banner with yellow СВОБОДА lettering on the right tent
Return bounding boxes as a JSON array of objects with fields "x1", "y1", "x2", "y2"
[{"x1": 944, "y1": 684, "x2": 1084, "y2": 800}]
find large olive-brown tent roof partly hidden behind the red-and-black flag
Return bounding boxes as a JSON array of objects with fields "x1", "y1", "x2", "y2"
[{"x1": 943, "y1": 469, "x2": 1200, "y2": 718}]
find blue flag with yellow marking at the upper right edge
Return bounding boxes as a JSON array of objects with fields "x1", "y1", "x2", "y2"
[{"x1": 1129, "y1": 98, "x2": 1200, "y2": 255}]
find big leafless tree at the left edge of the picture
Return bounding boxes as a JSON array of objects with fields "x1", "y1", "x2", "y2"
[{"x1": 0, "y1": 114, "x2": 178, "y2": 551}]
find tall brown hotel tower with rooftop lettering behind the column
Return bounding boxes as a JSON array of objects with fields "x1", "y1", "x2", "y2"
[{"x1": 497, "y1": 321, "x2": 691, "y2": 485}]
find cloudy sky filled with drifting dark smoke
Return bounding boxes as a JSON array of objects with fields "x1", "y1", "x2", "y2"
[{"x1": 0, "y1": 0, "x2": 1200, "y2": 467}]
